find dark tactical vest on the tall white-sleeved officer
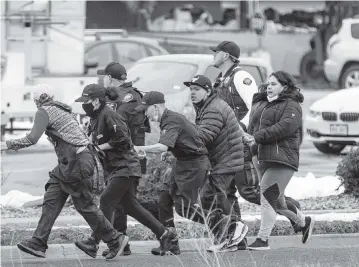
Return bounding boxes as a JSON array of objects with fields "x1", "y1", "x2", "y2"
[{"x1": 214, "y1": 64, "x2": 249, "y2": 122}]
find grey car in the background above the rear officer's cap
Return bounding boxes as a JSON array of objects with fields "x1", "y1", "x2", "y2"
[{"x1": 85, "y1": 34, "x2": 169, "y2": 75}]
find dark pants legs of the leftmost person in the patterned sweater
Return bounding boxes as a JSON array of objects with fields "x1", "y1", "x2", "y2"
[{"x1": 32, "y1": 183, "x2": 119, "y2": 248}]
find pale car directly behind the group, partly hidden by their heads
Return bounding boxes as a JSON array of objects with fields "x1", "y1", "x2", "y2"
[{"x1": 71, "y1": 54, "x2": 273, "y2": 118}]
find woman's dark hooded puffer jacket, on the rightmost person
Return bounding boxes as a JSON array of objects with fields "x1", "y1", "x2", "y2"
[{"x1": 248, "y1": 91, "x2": 304, "y2": 171}]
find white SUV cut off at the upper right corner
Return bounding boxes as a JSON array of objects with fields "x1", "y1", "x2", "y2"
[{"x1": 324, "y1": 18, "x2": 359, "y2": 88}]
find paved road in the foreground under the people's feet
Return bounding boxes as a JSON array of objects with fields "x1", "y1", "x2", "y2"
[{"x1": 1, "y1": 234, "x2": 359, "y2": 267}]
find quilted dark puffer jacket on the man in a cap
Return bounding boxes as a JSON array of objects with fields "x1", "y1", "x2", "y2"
[{"x1": 195, "y1": 94, "x2": 244, "y2": 174}]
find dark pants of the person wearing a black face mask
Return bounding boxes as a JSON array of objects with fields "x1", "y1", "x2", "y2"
[{"x1": 93, "y1": 176, "x2": 165, "y2": 243}]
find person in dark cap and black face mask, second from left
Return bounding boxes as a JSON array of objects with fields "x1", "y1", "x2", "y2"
[{"x1": 75, "y1": 84, "x2": 176, "y2": 257}]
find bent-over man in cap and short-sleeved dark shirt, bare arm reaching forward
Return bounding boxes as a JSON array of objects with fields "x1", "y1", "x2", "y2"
[{"x1": 135, "y1": 91, "x2": 238, "y2": 255}]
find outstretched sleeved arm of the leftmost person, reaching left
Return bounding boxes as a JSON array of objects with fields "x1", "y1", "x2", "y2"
[{"x1": 6, "y1": 108, "x2": 49, "y2": 150}]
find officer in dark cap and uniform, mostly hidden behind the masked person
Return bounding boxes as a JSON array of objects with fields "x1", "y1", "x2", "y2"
[{"x1": 97, "y1": 62, "x2": 150, "y2": 256}]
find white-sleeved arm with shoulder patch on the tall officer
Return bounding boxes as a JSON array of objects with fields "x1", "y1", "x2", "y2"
[{"x1": 233, "y1": 70, "x2": 258, "y2": 126}]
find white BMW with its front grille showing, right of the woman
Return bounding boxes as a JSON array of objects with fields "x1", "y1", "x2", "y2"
[{"x1": 306, "y1": 87, "x2": 359, "y2": 154}]
